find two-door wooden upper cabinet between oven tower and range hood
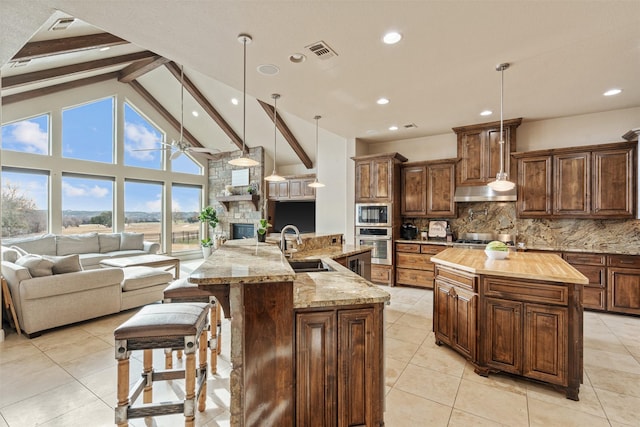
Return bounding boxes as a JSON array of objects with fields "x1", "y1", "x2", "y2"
[{"x1": 400, "y1": 159, "x2": 456, "y2": 218}]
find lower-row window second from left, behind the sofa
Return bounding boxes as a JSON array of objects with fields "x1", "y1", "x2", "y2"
[{"x1": 62, "y1": 174, "x2": 113, "y2": 234}]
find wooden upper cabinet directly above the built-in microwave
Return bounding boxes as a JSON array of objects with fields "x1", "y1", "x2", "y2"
[{"x1": 353, "y1": 153, "x2": 407, "y2": 203}]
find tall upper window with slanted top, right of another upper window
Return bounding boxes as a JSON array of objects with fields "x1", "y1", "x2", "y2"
[{"x1": 124, "y1": 102, "x2": 164, "y2": 169}]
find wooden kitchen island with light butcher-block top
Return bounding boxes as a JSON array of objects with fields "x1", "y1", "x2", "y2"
[{"x1": 431, "y1": 248, "x2": 588, "y2": 400}]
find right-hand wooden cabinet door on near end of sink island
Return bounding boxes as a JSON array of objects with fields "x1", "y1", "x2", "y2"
[{"x1": 338, "y1": 308, "x2": 384, "y2": 427}]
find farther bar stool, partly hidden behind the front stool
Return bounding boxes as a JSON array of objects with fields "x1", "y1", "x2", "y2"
[{"x1": 163, "y1": 279, "x2": 222, "y2": 374}]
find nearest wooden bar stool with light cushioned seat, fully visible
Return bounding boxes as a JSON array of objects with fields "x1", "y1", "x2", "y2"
[{"x1": 113, "y1": 303, "x2": 210, "y2": 427}]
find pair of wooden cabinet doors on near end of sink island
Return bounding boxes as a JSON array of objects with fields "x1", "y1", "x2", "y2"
[{"x1": 295, "y1": 304, "x2": 384, "y2": 427}]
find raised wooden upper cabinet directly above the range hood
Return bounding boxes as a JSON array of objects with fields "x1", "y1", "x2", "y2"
[{"x1": 453, "y1": 118, "x2": 522, "y2": 185}]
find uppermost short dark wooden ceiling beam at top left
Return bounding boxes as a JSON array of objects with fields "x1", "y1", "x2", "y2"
[{"x1": 11, "y1": 33, "x2": 129, "y2": 61}]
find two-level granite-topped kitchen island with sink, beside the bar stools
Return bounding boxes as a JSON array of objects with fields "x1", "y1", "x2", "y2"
[{"x1": 189, "y1": 240, "x2": 390, "y2": 426}]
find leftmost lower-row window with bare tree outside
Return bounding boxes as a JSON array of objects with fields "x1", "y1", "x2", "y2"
[{"x1": 2, "y1": 168, "x2": 49, "y2": 237}]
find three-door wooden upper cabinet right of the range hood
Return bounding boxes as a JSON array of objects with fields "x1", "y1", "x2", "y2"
[{"x1": 514, "y1": 143, "x2": 636, "y2": 219}]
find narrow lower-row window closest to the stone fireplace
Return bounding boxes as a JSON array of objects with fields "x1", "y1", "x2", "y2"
[{"x1": 171, "y1": 184, "x2": 202, "y2": 253}]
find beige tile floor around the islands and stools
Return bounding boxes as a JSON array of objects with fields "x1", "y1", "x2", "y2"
[{"x1": 0, "y1": 262, "x2": 640, "y2": 427}]
